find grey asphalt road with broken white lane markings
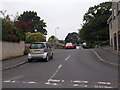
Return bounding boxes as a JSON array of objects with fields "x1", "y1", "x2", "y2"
[{"x1": 2, "y1": 49, "x2": 118, "y2": 88}]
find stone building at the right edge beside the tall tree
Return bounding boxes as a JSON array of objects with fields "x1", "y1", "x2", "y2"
[{"x1": 108, "y1": 1, "x2": 120, "y2": 51}]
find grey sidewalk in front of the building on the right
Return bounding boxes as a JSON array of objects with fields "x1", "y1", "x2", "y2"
[{"x1": 94, "y1": 46, "x2": 120, "y2": 65}]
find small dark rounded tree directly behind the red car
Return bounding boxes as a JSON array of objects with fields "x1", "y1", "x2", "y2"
[{"x1": 65, "y1": 32, "x2": 78, "y2": 44}]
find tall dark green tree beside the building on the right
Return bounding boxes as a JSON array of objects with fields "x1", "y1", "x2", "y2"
[{"x1": 79, "y1": 2, "x2": 111, "y2": 47}]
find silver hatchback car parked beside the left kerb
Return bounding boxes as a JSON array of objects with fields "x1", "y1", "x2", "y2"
[{"x1": 28, "y1": 42, "x2": 53, "y2": 62}]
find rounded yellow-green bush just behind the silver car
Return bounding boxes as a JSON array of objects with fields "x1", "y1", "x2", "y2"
[{"x1": 26, "y1": 32, "x2": 46, "y2": 43}]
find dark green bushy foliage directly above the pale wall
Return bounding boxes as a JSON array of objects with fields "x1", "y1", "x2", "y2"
[{"x1": 2, "y1": 19, "x2": 25, "y2": 42}]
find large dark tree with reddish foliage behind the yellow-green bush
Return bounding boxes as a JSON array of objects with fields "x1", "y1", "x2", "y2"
[{"x1": 15, "y1": 11, "x2": 47, "y2": 35}]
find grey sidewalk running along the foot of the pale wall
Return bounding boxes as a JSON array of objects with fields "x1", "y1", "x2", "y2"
[{"x1": 2, "y1": 55, "x2": 27, "y2": 70}]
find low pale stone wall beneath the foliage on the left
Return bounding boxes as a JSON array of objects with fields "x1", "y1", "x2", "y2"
[{"x1": 0, "y1": 41, "x2": 25, "y2": 60}]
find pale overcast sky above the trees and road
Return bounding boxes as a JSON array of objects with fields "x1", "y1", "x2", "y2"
[{"x1": 0, "y1": 0, "x2": 109, "y2": 40}]
